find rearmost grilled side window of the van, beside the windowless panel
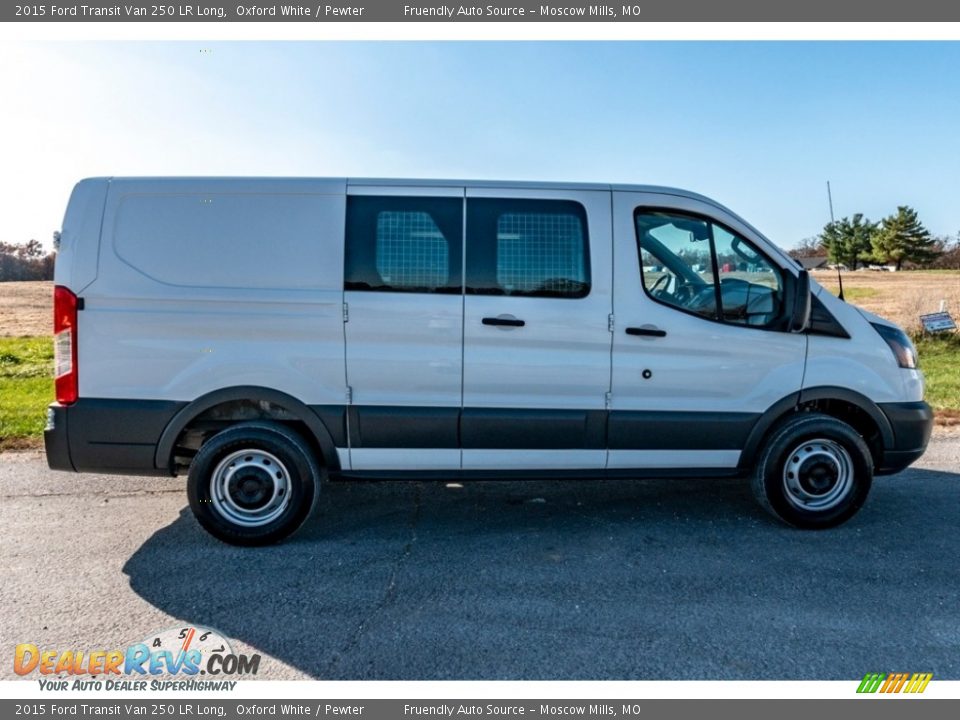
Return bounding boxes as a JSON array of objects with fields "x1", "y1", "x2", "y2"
[{"x1": 344, "y1": 195, "x2": 463, "y2": 293}]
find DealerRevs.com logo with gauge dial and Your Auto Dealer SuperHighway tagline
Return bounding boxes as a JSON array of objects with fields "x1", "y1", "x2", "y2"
[{"x1": 13, "y1": 627, "x2": 260, "y2": 690}]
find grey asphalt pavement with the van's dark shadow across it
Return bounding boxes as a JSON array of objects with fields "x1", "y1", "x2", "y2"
[{"x1": 0, "y1": 437, "x2": 960, "y2": 680}]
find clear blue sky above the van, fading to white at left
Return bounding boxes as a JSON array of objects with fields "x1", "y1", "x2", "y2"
[{"x1": 0, "y1": 42, "x2": 960, "y2": 252}]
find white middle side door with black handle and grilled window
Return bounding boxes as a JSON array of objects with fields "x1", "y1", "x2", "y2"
[{"x1": 460, "y1": 188, "x2": 611, "y2": 470}]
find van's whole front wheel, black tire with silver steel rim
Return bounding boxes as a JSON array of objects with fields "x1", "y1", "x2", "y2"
[{"x1": 751, "y1": 412, "x2": 873, "y2": 529}]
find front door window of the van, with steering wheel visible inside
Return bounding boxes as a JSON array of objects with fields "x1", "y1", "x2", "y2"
[{"x1": 634, "y1": 209, "x2": 783, "y2": 327}]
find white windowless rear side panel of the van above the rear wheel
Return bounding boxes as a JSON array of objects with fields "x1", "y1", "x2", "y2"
[{"x1": 79, "y1": 178, "x2": 345, "y2": 404}]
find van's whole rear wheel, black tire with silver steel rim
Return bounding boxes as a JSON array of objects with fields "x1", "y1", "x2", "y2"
[{"x1": 187, "y1": 422, "x2": 321, "y2": 545}]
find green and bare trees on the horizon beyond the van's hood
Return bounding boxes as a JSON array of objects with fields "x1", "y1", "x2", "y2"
[{"x1": 790, "y1": 205, "x2": 960, "y2": 270}]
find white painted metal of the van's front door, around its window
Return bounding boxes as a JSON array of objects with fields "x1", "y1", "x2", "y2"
[{"x1": 611, "y1": 192, "x2": 807, "y2": 413}]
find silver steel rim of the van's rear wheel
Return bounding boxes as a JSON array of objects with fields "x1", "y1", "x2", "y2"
[{"x1": 210, "y1": 449, "x2": 291, "y2": 527}]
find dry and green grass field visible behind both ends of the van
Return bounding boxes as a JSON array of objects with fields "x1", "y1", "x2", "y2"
[{"x1": 0, "y1": 270, "x2": 960, "y2": 449}]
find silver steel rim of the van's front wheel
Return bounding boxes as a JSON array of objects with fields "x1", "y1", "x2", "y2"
[{"x1": 783, "y1": 438, "x2": 853, "y2": 512}]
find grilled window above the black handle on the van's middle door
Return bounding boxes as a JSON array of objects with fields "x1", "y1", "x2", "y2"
[{"x1": 467, "y1": 198, "x2": 590, "y2": 298}]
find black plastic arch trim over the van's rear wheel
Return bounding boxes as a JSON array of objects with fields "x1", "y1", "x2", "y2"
[{"x1": 154, "y1": 385, "x2": 340, "y2": 473}]
